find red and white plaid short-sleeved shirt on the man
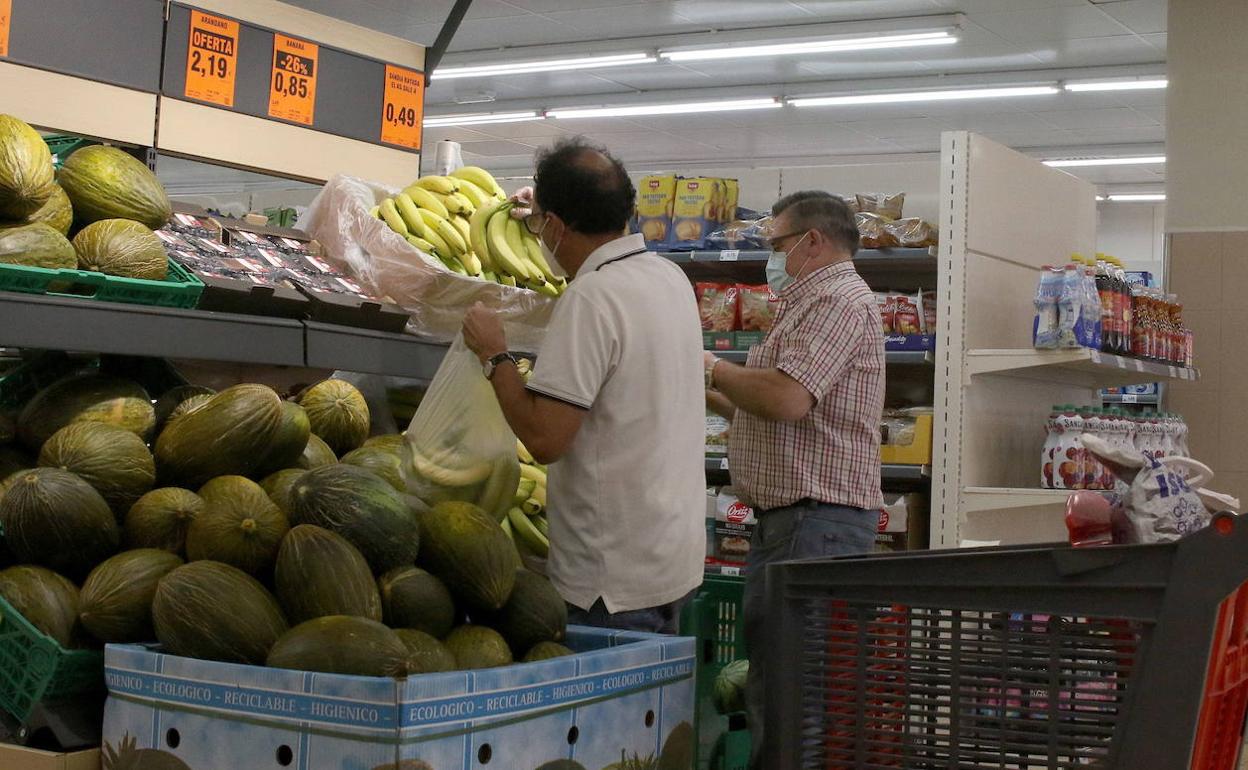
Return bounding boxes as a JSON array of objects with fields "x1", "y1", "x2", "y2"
[{"x1": 728, "y1": 262, "x2": 884, "y2": 510}]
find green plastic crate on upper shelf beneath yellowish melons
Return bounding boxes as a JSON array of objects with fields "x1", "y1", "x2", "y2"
[{"x1": 0, "y1": 260, "x2": 203, "y2": 308}]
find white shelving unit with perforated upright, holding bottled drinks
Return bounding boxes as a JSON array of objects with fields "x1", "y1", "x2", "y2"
[{"x1": 931, "y1": 131, "x2": 1199, "y2": 548}]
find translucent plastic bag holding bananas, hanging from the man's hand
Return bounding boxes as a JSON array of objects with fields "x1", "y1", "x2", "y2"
[{"x1": 403, "y1": 337, "x2": 520, "y2": 522}]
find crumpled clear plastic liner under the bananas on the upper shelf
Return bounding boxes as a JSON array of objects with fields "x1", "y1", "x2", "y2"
[{"x1": 300, "y1": 175, "x2": 555, "y2": 352}]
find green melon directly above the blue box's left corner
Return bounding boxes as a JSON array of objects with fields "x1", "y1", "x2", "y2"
[{"x1": 79, "y1": 548, "x2": 182, "y2": 644}]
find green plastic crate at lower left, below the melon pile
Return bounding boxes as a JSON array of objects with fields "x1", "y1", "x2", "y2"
[{"x1": 0, "y1": 598, "x2": 104, "y2": 723}]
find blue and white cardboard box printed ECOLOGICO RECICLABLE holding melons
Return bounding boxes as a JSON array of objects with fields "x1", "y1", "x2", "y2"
[{"x1": 104, "y1": 626, "x2": 695, "y2": 770}]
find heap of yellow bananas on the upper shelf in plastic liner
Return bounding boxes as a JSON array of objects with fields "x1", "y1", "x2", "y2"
[{"x1": 371, "y1": 166, "x2": 567, "y2": 297}]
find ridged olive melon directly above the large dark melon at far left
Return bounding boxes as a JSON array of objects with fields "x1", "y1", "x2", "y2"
[{"x1": 39, "y1": 422, "x2": 156, "y2": 517}]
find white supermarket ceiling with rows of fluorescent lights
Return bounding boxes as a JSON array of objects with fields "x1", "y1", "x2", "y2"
[{"x1": 290, "y1": 0, "x2": 1166, "y2": 183}]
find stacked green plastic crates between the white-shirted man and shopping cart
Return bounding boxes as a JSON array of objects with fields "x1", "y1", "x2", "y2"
[{"x1": 680, "y1": 575, "x2": 750, "y2": 770}]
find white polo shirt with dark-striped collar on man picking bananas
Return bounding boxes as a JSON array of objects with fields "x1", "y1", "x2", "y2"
[{"x1": 528, "y1": 235, "x2": 706, "y2": 613}]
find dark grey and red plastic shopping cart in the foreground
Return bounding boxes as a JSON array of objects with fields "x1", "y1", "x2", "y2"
[{"x1": 765, "y1": 514, "x2": 1248, "y2": 770}]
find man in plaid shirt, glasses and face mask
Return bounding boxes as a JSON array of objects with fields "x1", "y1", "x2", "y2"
[{"x1": 705, "y1": 192, "x2": 884, "y2": 770}]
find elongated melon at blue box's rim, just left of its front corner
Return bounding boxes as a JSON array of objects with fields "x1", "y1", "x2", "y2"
[{"x1": 266, "y1": 615, "x2": 407, "y2": 676}]
